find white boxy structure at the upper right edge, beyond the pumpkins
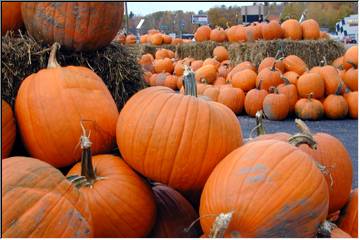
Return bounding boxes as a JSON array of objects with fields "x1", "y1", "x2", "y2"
[{"x1": 336, "y1": 14, "x2": 358, "y2": 42}]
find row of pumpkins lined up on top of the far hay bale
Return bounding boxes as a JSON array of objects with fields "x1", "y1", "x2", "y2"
[{"x1": 194, "y1": 19, "x2": 329, "y2": 43}]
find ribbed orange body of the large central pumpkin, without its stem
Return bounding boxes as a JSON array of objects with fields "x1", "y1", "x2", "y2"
[{"x1": 116, "y1": 87, "x2": 242, "y2": 191}]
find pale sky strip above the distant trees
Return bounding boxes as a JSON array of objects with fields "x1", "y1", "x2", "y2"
[{"x1": 128, "y1": 2, "x2": 252, "y2": 16}]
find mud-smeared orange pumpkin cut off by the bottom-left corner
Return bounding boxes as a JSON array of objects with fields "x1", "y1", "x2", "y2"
[{"x1": 1, "y1": 157, "x2": 93, "y2": 238}]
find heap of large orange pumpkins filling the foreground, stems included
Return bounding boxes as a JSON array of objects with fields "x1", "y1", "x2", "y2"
[{"x1": 2, "y1": 39, "x2": 357, "y2": 237}]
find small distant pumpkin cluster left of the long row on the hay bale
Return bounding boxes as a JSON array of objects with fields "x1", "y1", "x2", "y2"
[{"x1": 114, "y1": 29, "x2": 192, "y2": 46}]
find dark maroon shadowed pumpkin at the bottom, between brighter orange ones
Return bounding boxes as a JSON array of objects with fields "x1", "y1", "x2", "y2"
[{"x1": 150, "y1": 184, "x2": 199, "y2": 238}]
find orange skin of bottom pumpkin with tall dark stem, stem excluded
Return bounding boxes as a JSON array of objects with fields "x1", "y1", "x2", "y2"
[{"x1": 67, "y1": 154, "x2": 156, "y2": 238}]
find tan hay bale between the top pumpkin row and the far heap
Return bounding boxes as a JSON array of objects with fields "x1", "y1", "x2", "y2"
[{"x1": 228, "y1": 40, "x2": 345, "y2": 68}]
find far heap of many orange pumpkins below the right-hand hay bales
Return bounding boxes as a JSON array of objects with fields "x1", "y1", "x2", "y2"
[{"x1": 139, "y1": 46, "x2": 358, "y2": 120}]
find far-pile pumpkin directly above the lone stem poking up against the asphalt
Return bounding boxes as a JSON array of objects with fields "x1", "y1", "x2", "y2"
[{"x1": 244, "y1": 85, "x2": 268, "y2": 117}]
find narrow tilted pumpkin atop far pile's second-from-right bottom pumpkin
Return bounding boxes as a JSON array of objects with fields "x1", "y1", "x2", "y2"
[{"x1": 321, "y1": 65, "x2": 346, "y2": 95}]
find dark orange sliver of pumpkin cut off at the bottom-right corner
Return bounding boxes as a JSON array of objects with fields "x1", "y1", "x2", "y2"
[{"x1": 338, "y1": 188, "x2": 359, "y2": 238}]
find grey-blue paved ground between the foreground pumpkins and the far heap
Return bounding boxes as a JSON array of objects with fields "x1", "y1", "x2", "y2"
[{"x1": 238, "y1": 116, "x2": 358, "y2": 188}]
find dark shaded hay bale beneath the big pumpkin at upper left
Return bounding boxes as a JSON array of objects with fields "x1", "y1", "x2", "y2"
[{"x1": 1, "y1": 32, "x2": 145, "y2": 109}]
